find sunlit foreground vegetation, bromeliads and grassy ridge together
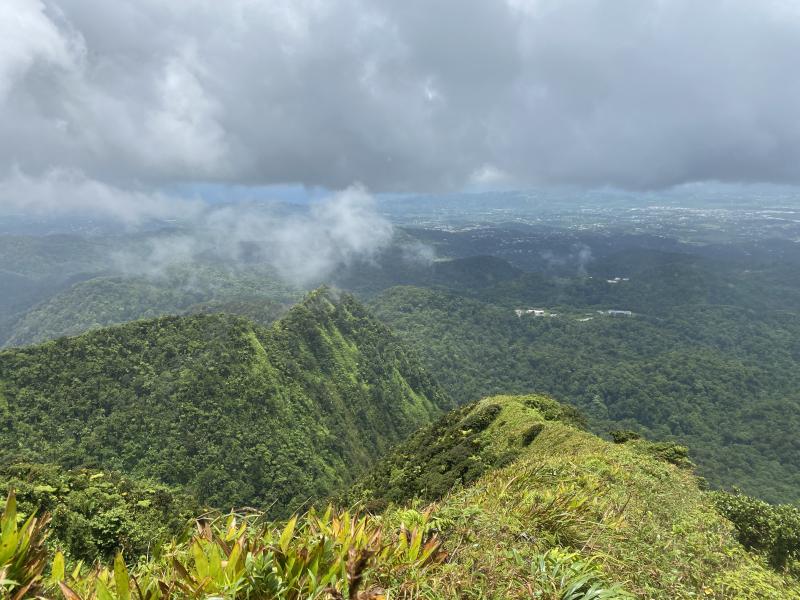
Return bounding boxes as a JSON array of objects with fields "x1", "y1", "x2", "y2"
[{"x1": 0, "y1": 396, "x2": 800, "y2": 600}]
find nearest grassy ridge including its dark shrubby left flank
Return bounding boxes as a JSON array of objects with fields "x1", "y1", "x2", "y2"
[{"x1": 350, "y1": 396, "x2": 800, "y2": 599}]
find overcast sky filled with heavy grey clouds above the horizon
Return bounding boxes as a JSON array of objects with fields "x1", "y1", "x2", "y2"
[{"x1": 0, "y1": 0, "x2": 800, "y2": 221}]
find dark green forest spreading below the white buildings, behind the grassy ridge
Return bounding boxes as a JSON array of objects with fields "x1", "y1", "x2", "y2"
[{"x1": 372, "y1": 286, "x2": 800, "y2": 502}]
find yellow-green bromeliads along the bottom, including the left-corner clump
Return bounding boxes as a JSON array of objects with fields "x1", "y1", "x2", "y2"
[{"x1": 0, "y1": 494, "x2": 450, "y2": 600}]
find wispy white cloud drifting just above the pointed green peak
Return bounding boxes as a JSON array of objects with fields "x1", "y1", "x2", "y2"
[{"x1": 115, "y1": 187, "x2": 393, "y2": 285}]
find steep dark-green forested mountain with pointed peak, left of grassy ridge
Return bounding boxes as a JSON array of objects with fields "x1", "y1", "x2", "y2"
[{"x1": 0, "y1": 289, "x2": 450, "y2": 514}]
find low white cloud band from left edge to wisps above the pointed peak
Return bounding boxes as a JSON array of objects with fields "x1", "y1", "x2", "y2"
[{"x1": 0, "y1": 168, "x2": 394, "y2": 285}]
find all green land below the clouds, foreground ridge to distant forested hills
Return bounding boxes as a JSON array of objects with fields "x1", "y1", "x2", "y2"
[{"x1": 0, "y1": 228, "x2": 800, "y2": 600}]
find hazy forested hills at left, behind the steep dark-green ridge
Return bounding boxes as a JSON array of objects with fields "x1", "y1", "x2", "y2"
[{"x1": 0, "y1": 229, "x2": 307, "y2": 347}]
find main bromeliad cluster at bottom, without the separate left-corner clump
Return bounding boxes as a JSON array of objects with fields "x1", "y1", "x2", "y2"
[{"x1": 53, "y1": 508, "x2": 443, "y2": 600}]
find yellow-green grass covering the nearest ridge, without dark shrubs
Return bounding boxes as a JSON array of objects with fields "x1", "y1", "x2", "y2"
[{"x1": 372, "y1": 397, "x2": 800, "y2": 599}]
